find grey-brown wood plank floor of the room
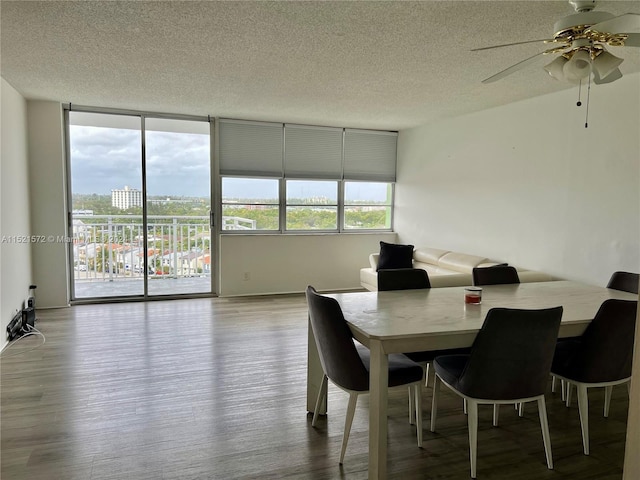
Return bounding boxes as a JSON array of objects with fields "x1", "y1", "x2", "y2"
[{"x1": 0, "y1": 295, "x2": 628, "y2": 480}]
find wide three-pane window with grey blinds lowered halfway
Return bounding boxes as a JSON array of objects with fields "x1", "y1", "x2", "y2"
[{"x1": 218, "y1": 119, "x2": 398, "y2": 233}]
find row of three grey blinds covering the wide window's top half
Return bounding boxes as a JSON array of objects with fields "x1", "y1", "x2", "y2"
[{"x1": 219, "y1": 119, "x2": 398, "y2": 182}]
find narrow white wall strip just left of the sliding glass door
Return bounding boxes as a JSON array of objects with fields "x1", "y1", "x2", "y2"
[{"x1": 27, "y1": 100, "x2": 69, "y2": 307}]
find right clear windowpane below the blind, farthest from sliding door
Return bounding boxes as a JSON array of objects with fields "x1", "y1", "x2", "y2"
[{"x1": 343, "y1": 182, "x2": 393, "y2": 230}]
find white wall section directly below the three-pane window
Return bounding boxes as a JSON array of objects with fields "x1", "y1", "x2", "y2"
[{"x1": 219, "y1": 233, "x2": 396, "y2": 296}]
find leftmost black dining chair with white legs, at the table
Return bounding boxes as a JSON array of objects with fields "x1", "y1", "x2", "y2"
[{"x1": 306, "y1": 286, "x2": 422, "y2": 464}]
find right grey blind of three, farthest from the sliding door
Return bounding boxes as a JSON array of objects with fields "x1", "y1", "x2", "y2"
[{"x1": 344, "y1": 129, "x2": 398, "y2": 182}]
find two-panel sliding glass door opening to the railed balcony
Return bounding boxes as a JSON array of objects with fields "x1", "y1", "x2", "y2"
[{"x1": 68, "y1": 111, "x2": 213, "y2": 299}]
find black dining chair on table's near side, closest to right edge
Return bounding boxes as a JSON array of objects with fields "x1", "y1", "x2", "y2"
[{"x1": 551, "y1": 299, "x2": 638, "y2": 455}]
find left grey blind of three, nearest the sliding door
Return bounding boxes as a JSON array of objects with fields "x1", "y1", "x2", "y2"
[{"x1": 219, "y1": 119, "x2": 283, "y2": 177}]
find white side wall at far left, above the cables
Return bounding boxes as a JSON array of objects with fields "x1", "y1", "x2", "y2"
[{"x1": 0, "y1": 79, "x2": 31, "y2": 348}]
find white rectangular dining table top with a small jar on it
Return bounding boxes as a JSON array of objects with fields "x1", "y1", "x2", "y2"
[{"x1": 329, "y1": 281, "x2": 638, "y2": 353}]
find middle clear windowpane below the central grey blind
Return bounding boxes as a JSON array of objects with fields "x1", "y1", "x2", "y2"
[{"x1": 285, "y1": 180, "x2": 338, "y2": 230}]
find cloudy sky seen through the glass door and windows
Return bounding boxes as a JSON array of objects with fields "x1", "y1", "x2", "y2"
[{"x1": 70, "y1": 125, "x2": 387, "y2": 201}]
